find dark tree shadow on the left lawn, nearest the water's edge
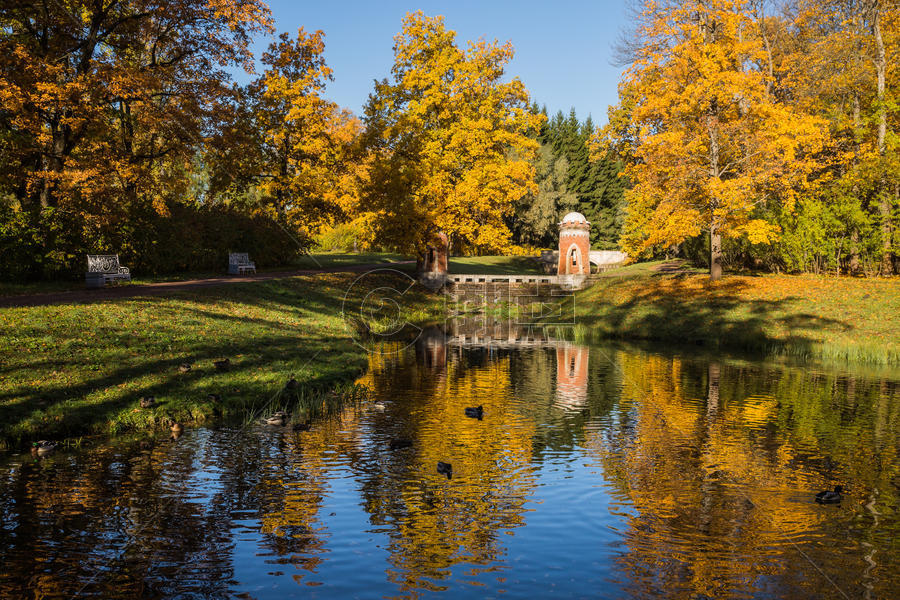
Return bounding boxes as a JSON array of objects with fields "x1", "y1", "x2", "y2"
[{"x1": 0, "y1": 336, "x2": 364, "y2": 446}]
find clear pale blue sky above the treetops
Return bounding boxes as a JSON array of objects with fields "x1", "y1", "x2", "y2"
[{"x1": 236, "y1": 0, "x2": 626, "y2": 124}]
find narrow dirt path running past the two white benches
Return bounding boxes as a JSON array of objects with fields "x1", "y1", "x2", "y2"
[{"x1": 0, "y1": 261, "x2": 415, "y2": 308}]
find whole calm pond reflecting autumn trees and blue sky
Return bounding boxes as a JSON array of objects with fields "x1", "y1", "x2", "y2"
[{"x1": 0, "y1": 328, "x2": 900, "y2": 598}]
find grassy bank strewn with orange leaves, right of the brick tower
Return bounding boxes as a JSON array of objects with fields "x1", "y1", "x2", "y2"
[{"x1": 575, "y1": 263, "x2": 900, "y2": 364}]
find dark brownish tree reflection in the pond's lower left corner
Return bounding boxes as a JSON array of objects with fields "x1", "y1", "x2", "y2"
[{"x1": 0, "y1": 434, "x2": 231, "y2": 598}]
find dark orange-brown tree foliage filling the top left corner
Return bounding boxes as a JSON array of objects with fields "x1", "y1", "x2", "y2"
[{"x1": 0, "y1": 0, "x2": 270, "y2": 207}]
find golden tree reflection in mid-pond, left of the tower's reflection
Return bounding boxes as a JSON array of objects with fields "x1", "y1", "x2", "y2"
[{"x1": 361, "y1": 338, "x2": 535, "y2": 591}]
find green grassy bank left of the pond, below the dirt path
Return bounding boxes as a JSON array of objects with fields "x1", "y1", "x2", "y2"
[{"x1": 0, "y1": 274, "x2": 438, "y2": 448}]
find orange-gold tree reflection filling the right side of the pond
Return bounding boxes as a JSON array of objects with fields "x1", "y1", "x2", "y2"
[{"x1": 589, "y1": 352, "x2": 900, "y2": 597}]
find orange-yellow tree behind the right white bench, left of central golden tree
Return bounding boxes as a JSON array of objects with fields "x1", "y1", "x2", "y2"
[{"x1": 209, "y1": 27, "x2": 361, "y2": 234}]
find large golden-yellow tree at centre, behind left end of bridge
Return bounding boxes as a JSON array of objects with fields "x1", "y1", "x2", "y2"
[{"x1": 364, "y1": 12, "x2": 542, "y2": 255}]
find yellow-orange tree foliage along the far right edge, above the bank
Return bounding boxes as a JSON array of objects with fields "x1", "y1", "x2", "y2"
[{"x1": 783, "y1": 0, "x2": 900, "y2": 274}]
